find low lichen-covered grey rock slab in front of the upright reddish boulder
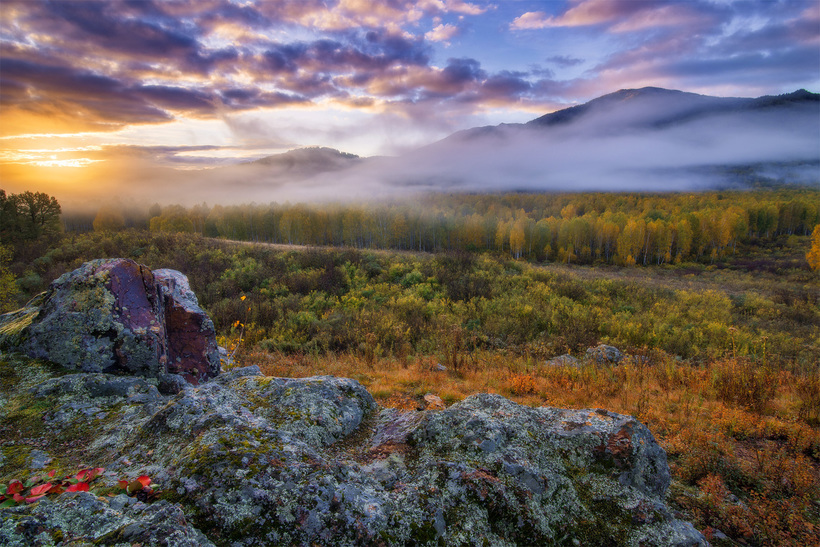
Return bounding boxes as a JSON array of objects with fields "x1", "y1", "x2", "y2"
[{"x1": 0, "y1": 356, "x2": 705, "y2": 546}]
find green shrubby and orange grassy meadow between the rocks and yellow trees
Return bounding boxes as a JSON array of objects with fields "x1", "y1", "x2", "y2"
[{"x1": 1, "y1": 187, "x2": 820, "y2": 545}]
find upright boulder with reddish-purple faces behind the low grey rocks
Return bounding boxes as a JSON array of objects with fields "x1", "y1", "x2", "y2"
[{"x1": 0, "y1": 258, "x2": 220, "y2": 384}]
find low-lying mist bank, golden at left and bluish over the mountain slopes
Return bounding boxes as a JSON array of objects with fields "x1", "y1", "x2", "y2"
[{"x1": 3, "y1": 88, "x2": 820, "y2": 214}]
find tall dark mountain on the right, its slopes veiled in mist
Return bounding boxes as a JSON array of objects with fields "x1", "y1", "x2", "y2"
[{"x1": 388, "y1": 87, "x2": 820, "y2": 191}]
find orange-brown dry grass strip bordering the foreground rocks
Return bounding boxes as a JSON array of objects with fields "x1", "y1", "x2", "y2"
[{"x1": 229, "y1": 352, "x2": 820, "y2": 546}]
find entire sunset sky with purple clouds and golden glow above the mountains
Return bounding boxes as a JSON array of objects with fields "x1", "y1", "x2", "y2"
[{"x1": 0, "y1": 0, "x2": 820, "y2": 206}]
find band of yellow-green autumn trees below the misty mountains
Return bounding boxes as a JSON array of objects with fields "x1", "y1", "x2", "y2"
[{"x1": 131, "y1": 188, "x2": 820, "y2": 265}]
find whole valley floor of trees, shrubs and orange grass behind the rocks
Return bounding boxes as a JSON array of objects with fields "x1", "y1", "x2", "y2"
[{"x1": 0, "y1": 187, "x2": 820, "y2": 545}]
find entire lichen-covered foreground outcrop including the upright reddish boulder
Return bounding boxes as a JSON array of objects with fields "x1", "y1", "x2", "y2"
[{"x1": 0, "y1": 260, "x2": 705, "y2": 546}]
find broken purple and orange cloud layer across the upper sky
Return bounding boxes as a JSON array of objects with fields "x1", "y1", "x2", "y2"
[{"x1": 0, "y1": 0, "x2": 820, "y2": 153}]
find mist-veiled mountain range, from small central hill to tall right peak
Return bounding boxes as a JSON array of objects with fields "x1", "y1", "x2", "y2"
[{"x1": 183, "y1": 87, "x2": 820, "y2": 202}]
